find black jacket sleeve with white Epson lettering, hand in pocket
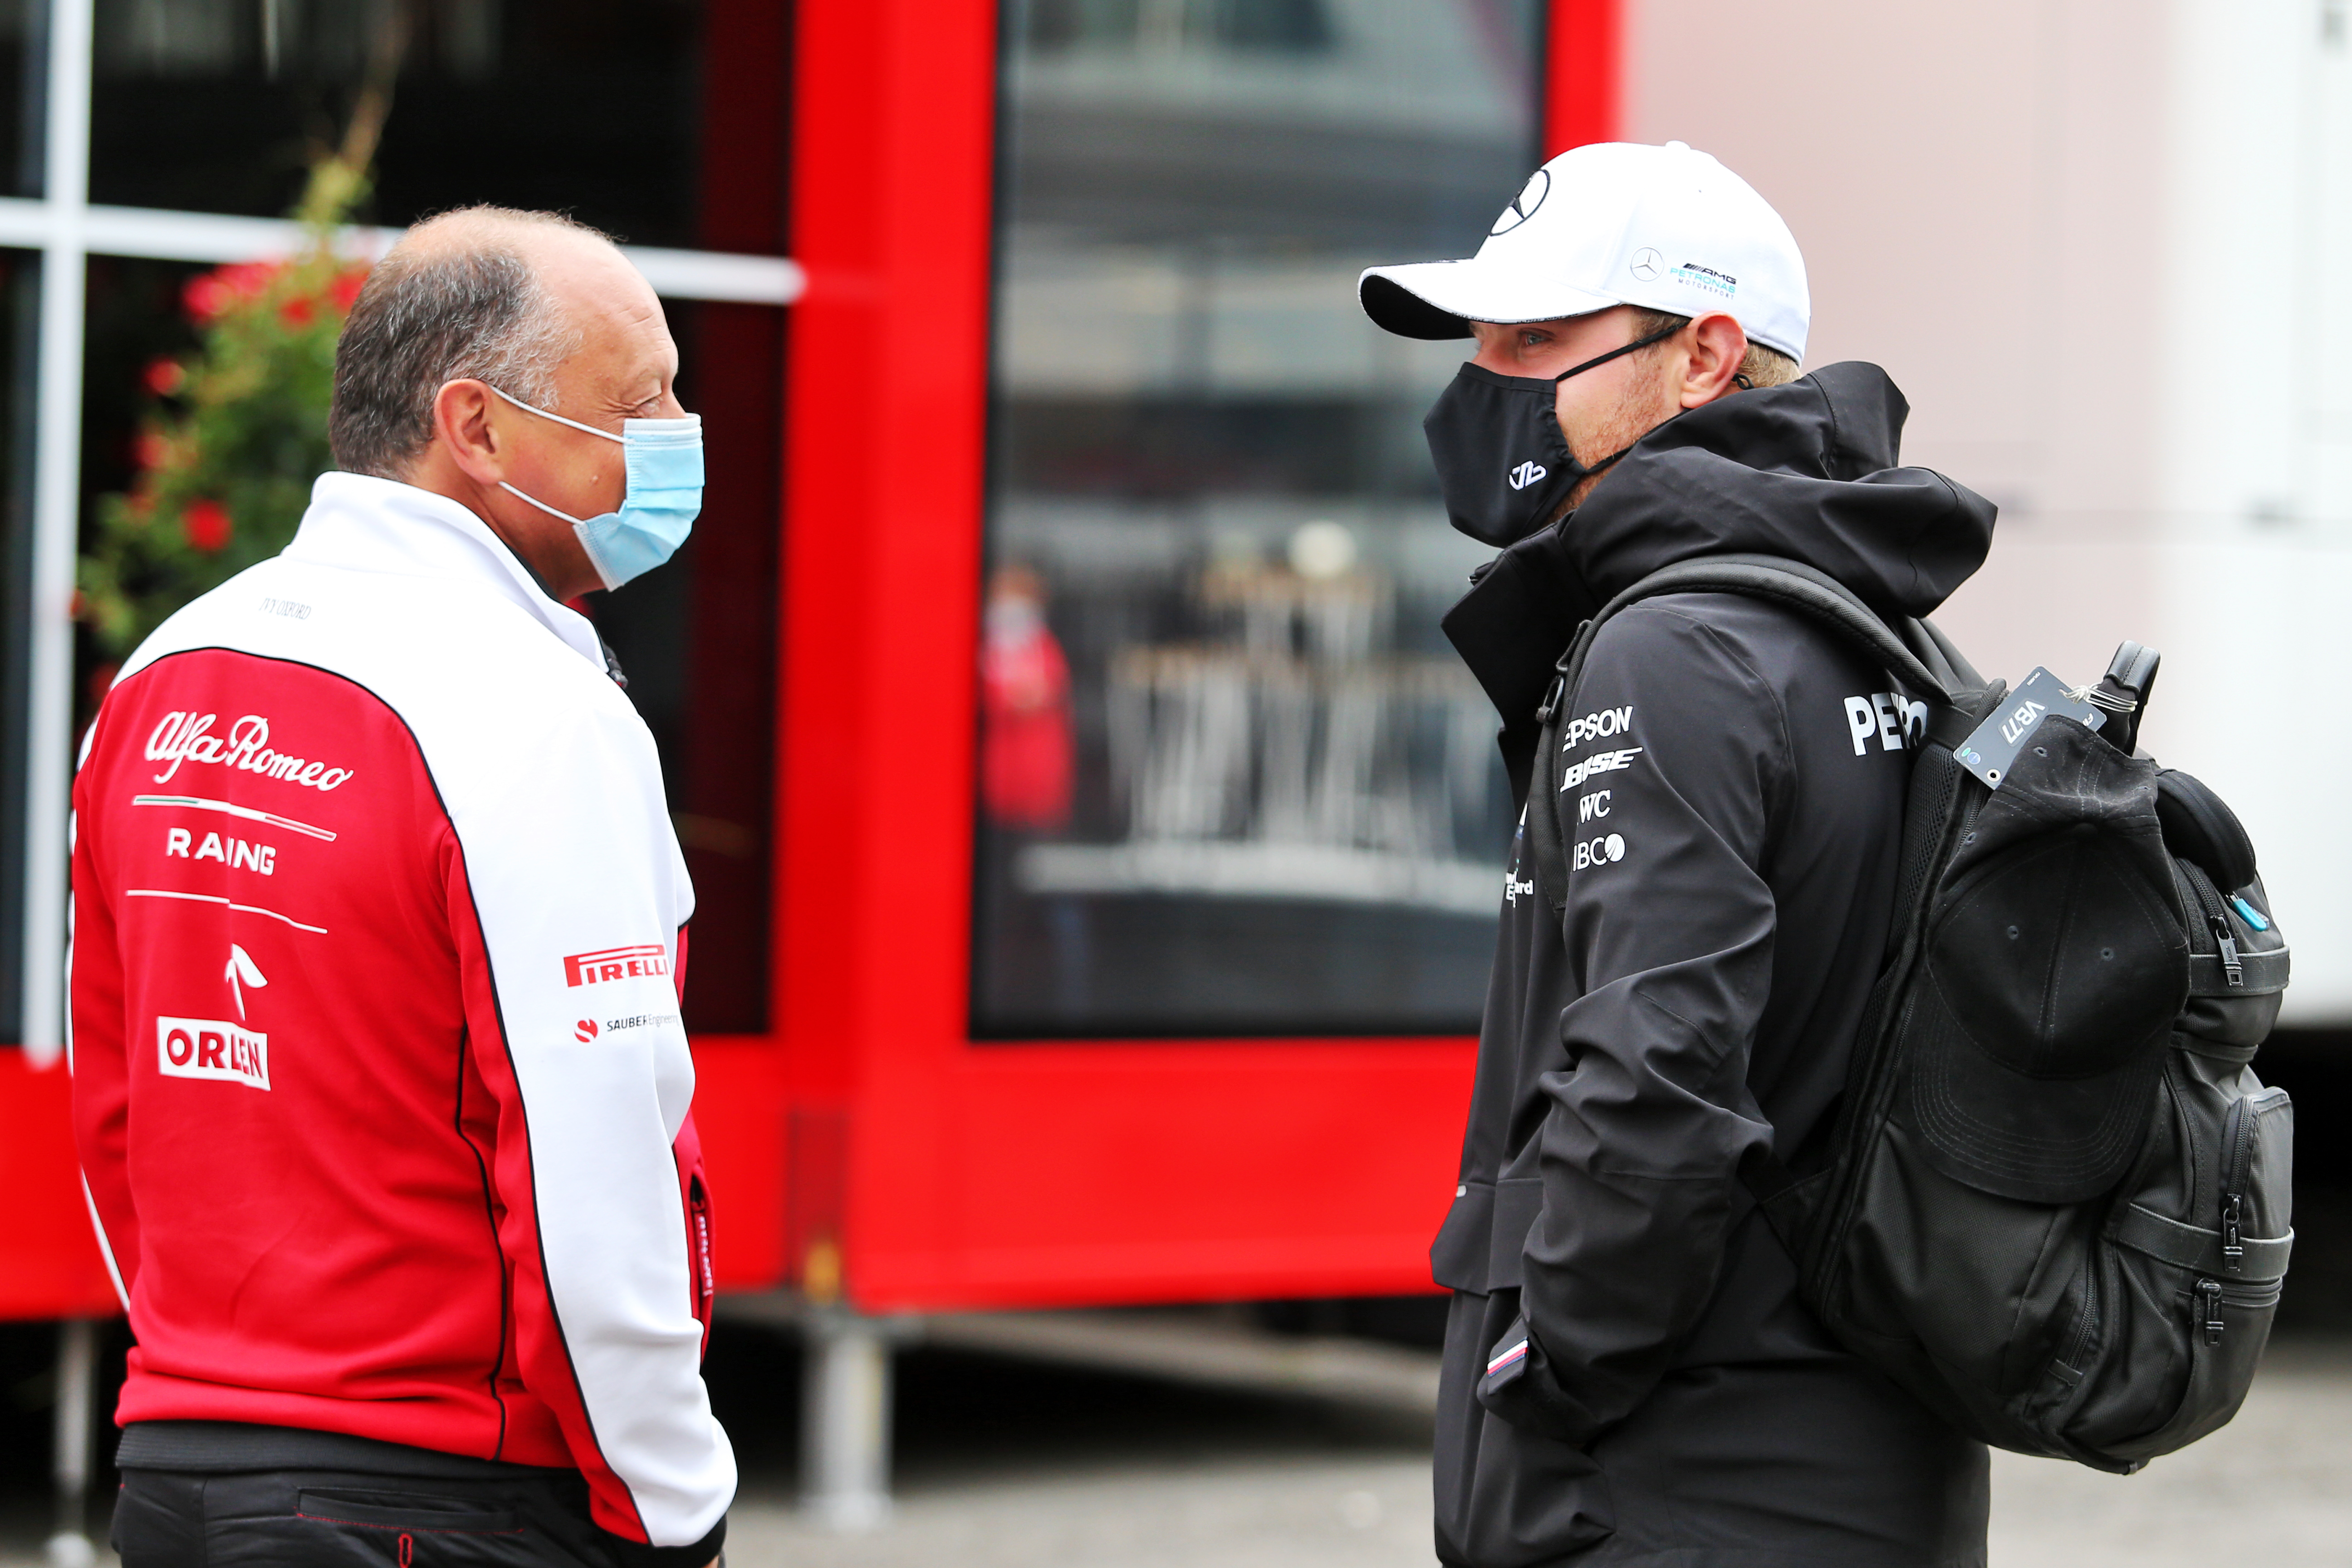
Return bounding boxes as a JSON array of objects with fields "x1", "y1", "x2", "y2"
[{"x1": 1480, "y1": 599, "x2": 1790, "y2": 1443}]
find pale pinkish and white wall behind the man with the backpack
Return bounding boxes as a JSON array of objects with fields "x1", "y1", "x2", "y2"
[{"x1": 1627, "y1": 0, "x2": 2352, "y2": 1023}]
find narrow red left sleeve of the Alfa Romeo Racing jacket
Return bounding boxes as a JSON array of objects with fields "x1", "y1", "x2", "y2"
[{"x1": 66, "y1": 717, "x2": 139, "y2": 1312}]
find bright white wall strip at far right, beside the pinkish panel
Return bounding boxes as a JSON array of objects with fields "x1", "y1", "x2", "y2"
[{"x1": 2150, "y1": 0, "x2": 2352, "y2": 1023}]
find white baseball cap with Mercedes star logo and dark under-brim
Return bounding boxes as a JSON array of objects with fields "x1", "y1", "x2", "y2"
[{"x1": 1355, "y1": 141, "x2": 1813, "y2": 362}]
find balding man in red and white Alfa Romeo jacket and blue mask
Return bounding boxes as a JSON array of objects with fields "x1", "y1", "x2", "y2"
[{"x1": 73, "y1": 209, "x2": 736, "y2": 1568}]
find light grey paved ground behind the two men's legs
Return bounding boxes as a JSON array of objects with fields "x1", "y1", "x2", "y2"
[{"x1": 729, "y1": 1345, "x2": 2352, "y2": 1568}]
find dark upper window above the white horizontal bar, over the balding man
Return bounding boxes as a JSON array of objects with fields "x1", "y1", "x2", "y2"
[{"x1": 85, "y1": 0, "x2": 790, "y2": 254}]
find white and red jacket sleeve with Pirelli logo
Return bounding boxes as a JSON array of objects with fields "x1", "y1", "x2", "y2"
[{"x1": 447, "y1": 703, "x2": 736, "y2": 1568}]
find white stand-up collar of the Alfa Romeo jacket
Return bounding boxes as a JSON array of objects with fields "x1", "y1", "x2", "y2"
[{"x1": 284, "y1": 472, "x2": 609, "y2": 670}]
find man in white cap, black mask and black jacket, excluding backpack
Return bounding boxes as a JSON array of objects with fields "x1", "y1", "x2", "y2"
[{"x1": 1359, "y1": 143, "x2": 1992, "y2": 1568}]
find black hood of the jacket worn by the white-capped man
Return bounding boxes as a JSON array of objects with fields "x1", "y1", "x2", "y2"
[{"x1": 1444, "y1": 362, "x2": 1994, "y2": 792}]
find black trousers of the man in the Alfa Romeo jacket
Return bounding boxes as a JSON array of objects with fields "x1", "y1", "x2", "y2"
[{"x1": 113, "y1": 1469, "x2": 640, "y2": 1568}]
